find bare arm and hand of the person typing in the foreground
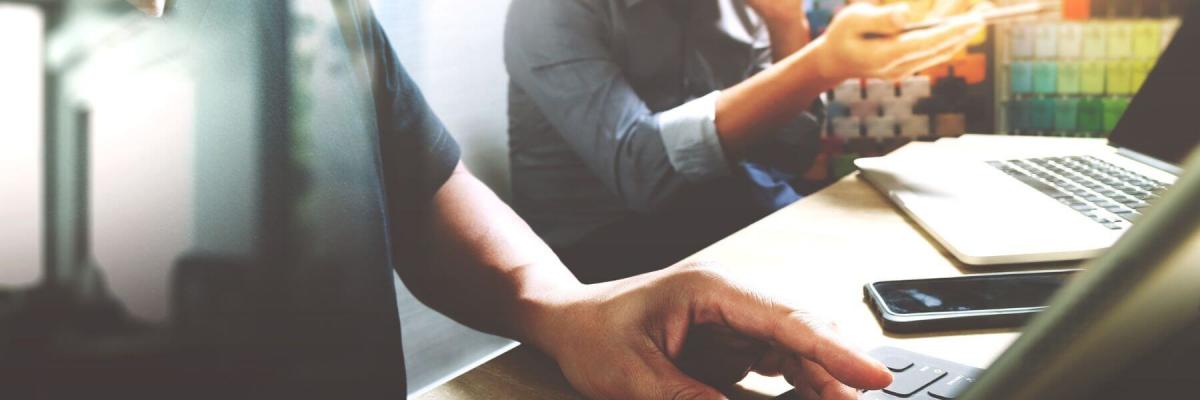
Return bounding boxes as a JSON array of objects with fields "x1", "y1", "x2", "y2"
[{"x1": 401, "y1": 165, "x2": 890, "y2": 399}]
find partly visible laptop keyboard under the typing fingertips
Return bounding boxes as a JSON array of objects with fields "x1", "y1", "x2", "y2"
[{"x1": 775, "y1": 347, "x2": 983, "y2": 400}]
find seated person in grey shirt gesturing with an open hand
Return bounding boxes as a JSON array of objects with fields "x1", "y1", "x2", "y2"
[{"x1": 505, "y1": 0, "x2": 982, "y2": 281}]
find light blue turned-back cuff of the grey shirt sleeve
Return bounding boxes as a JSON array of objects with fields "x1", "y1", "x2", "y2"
[{"x1": 659, "y1": 91, "x2": 730, "y2": 181}]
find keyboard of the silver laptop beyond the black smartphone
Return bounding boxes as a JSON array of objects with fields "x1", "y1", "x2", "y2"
[{"x1": 988, "y1": 156, "x2": 1168, "y2": 231}]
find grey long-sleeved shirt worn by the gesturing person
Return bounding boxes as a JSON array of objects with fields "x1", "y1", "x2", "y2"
[{"x1": 504, "y1": 0, "x2": 823, "y2": 246}]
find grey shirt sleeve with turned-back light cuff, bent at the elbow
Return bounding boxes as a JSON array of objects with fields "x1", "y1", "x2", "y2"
[{"x1": 504, "y1": 0, "x2": 728, "y2": 211}]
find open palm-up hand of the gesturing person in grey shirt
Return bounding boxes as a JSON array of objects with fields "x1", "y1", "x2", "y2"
[{"x1": 812, "y1": 2, "x2": 984, "y2": 82}]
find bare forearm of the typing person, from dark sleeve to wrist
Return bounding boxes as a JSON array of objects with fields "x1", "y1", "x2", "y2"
[{"x1": 401, "y1": 166, "x2": 582, "y2": 341}]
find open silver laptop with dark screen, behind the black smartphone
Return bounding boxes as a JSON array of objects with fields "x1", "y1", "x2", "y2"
[{"x1": 857, "y1": 6, "x2": 1200, "y2": 265}]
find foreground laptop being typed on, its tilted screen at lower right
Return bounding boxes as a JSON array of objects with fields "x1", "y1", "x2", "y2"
[{"x1": 778, "y1": 146, "x2": 1200, "y2": 400}]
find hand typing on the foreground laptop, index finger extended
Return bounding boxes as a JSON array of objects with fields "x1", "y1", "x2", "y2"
[{"x1": 528, "y1": 264, "x2": 892, "y2": 399}]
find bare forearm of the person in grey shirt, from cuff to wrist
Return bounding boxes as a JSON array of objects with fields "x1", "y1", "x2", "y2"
[{"x1": 716, "y1": 38, "x2": 839, "y2": 156}]
